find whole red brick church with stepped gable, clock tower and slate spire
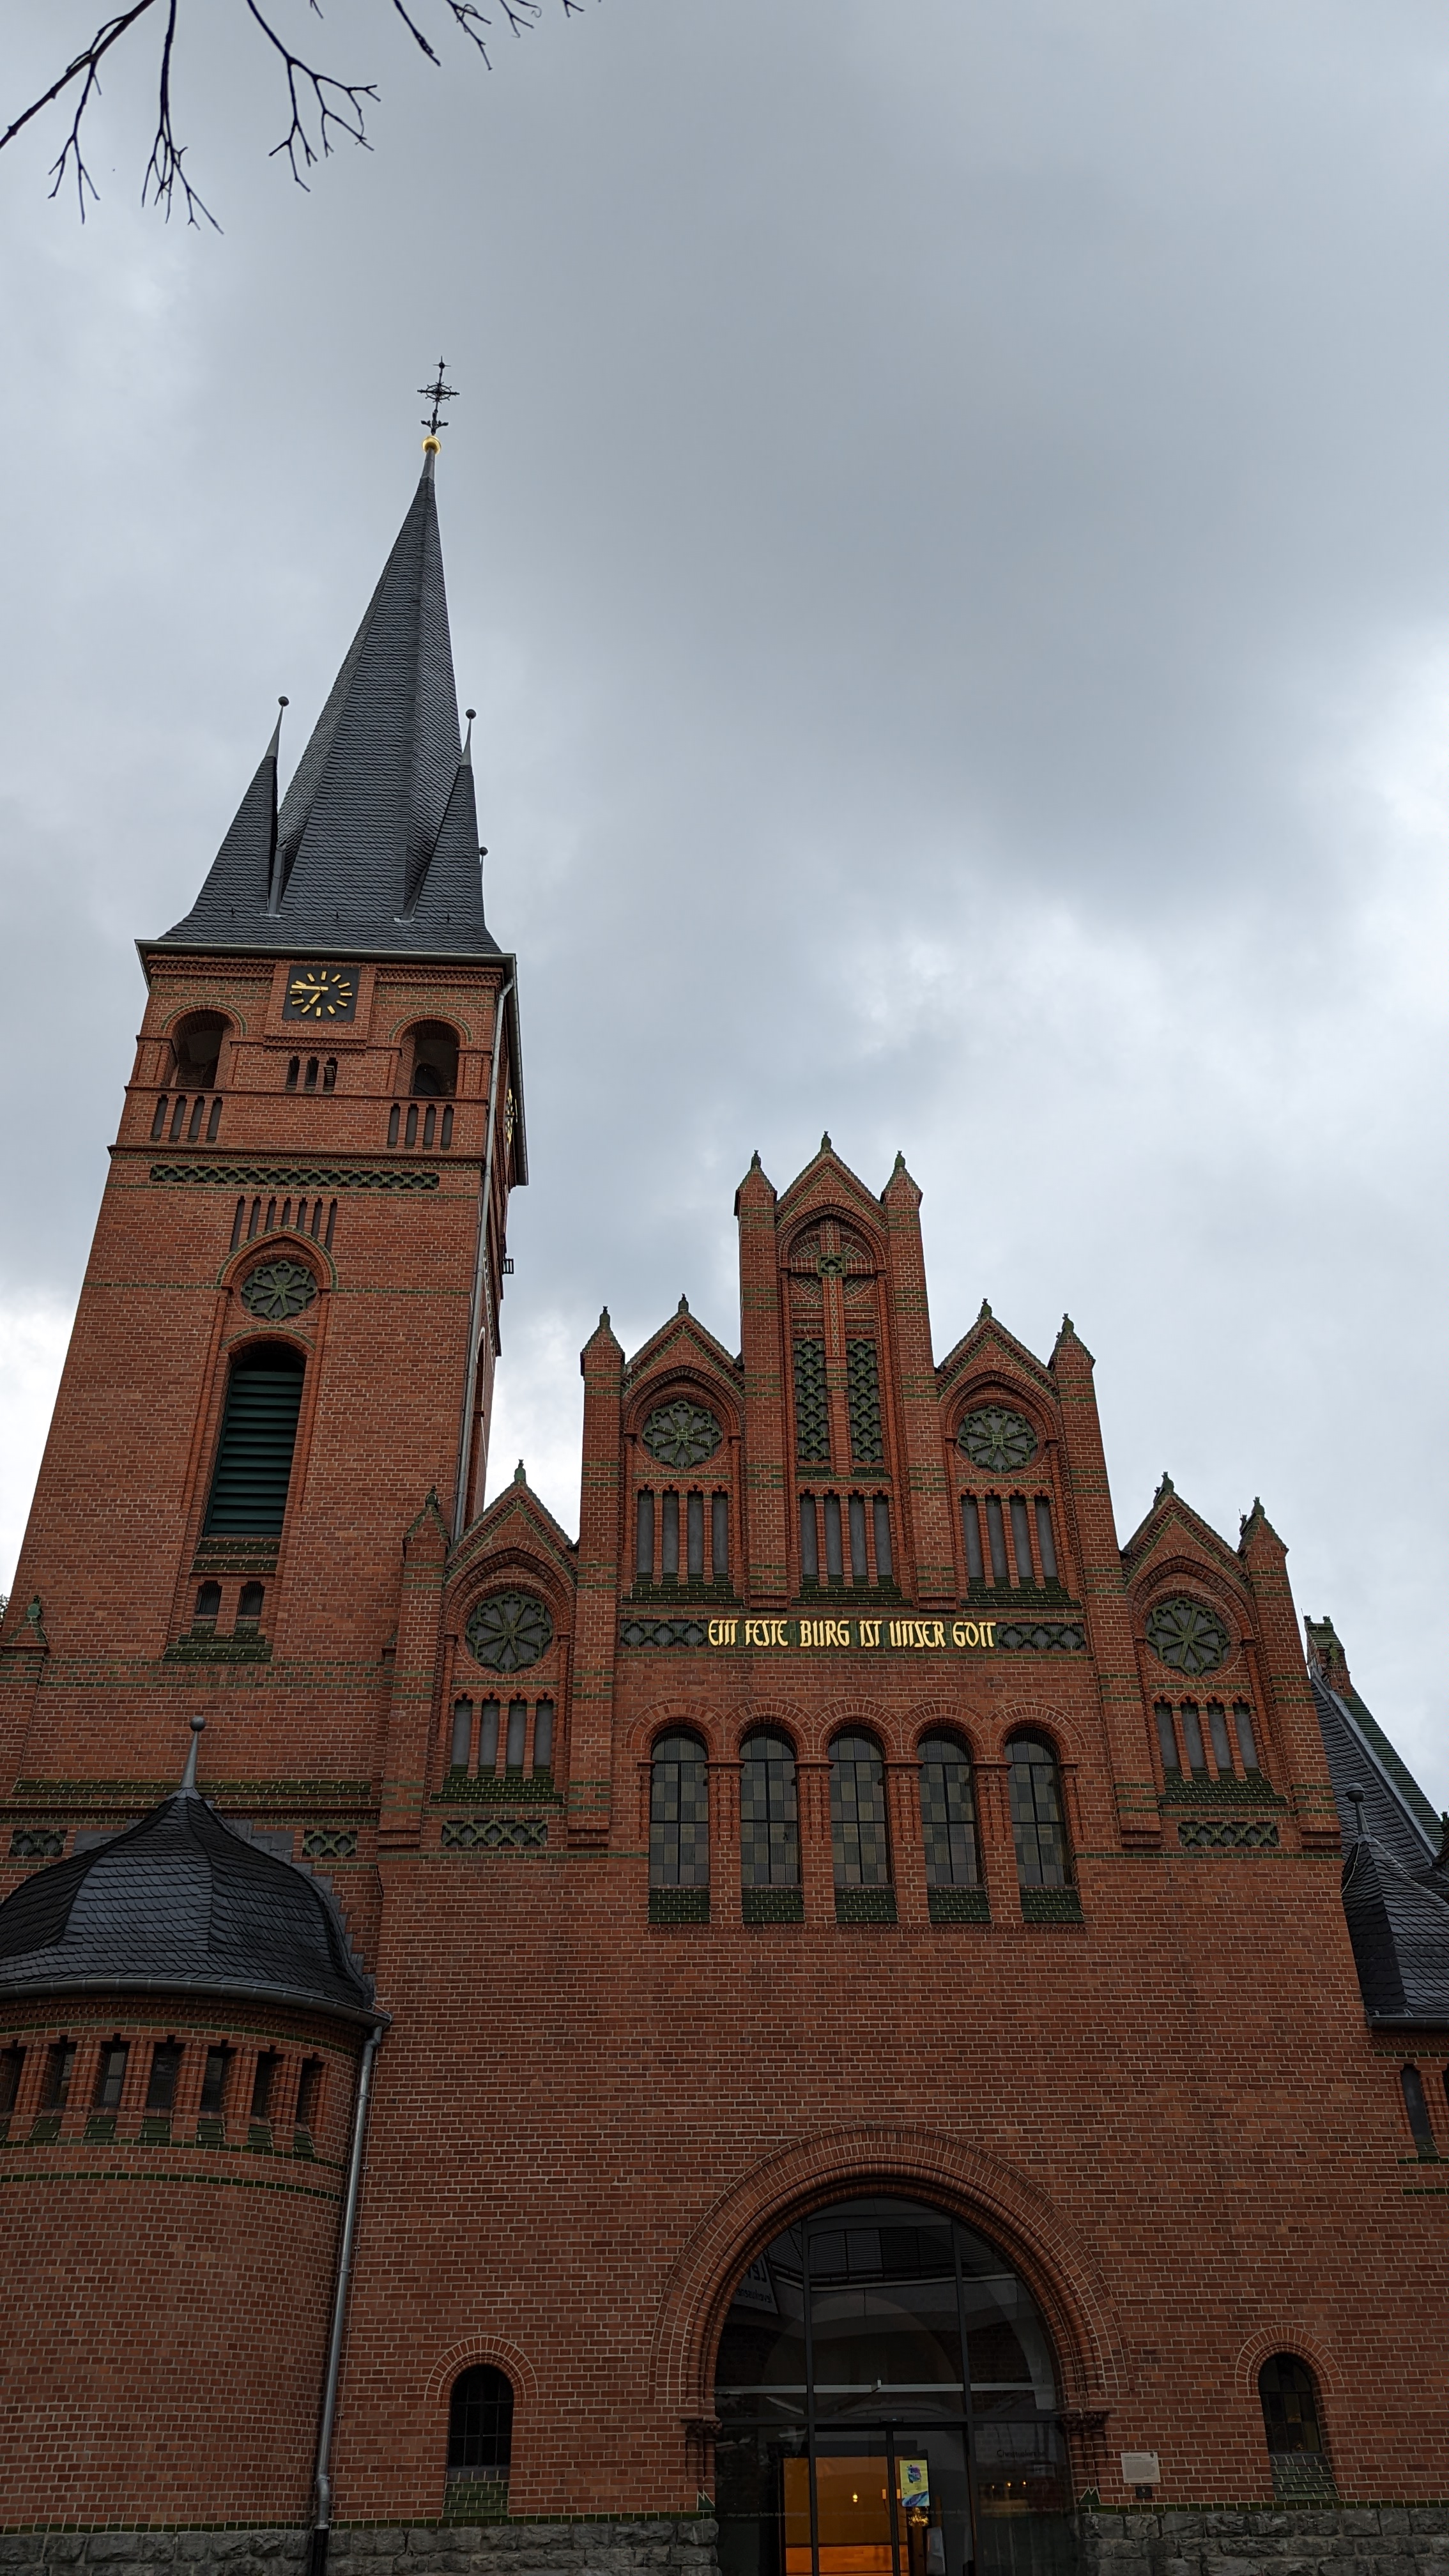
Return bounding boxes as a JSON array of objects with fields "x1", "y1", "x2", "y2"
[{"x1": 0, "y1": 440, "x2": 1449, "y2": 2576}]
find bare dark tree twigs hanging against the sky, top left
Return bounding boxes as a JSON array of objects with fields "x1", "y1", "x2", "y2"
[{"x1": 0, "y1": 0, "x2": 593, "y2": 229}]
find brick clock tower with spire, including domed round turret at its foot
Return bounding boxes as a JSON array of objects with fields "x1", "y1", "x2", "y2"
[{"x1": 0, "y1": 438, "x2": 526, "y2": 2524}]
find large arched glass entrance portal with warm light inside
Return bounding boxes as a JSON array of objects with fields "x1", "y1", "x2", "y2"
[{"x1": 714, "y1": 2195, "x2": 1075, "y2": 2576}]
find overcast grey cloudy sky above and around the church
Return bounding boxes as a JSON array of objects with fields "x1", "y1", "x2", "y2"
[{"x1": 0, "y1": 0, "x2": 1449, "y2": 1803}]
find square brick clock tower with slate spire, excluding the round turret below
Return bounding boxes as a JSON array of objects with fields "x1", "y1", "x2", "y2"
[{"x1": 0, "y1": 443, "x2": 526, "y2": 1821}]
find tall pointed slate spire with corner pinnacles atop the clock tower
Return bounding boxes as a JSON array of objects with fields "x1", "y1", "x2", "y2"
[{"x1": 157, "y1": 454, "x2": 500, "y2": 956}]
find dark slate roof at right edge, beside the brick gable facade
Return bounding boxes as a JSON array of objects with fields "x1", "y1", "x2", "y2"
[{"x1": 1310, "y1": 1667, "x2": 1449, "y2": 2030}]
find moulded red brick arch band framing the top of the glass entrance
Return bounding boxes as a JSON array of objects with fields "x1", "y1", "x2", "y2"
[{"x1": 652, "y1": 2128, "x2": 1127, "y2": 2416}]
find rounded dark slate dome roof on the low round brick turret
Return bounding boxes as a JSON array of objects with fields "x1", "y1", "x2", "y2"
[{"x1": 0, "y1": 1788, "x2": 384, "y2": 2022}]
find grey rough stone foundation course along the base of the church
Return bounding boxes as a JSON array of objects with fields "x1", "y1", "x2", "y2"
[{"x1": 0, "y1": 2504, "x2": 1449, "y2": 2576}]
